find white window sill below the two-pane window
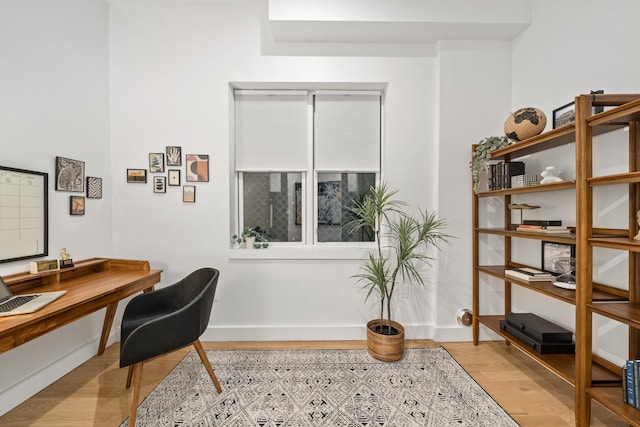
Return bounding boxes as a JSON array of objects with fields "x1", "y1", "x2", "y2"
[{"x1": 229, "y1": 246, "x2": 371, "y2": 260}]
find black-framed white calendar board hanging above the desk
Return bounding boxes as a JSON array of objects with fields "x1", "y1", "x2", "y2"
[{"x1": 0, "y1": 166, "x2": 49, "y2": 263}]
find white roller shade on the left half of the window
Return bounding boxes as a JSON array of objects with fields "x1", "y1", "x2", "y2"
[{"x1": 234, "y1": 91, "x2": 308, "y2": 171}]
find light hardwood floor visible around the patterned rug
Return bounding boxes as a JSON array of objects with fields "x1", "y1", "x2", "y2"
[{"x1": 0, "y1": 340, "x2": 627, "y2": 427}]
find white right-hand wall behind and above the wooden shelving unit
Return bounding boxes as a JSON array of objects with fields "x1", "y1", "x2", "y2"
[{"x1": 511, "y1": 0, "x2": 640, "y2": 363}]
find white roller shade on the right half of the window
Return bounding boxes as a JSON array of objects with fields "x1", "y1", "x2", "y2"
[{"x1": 314, "y1": 91, "x2": 380, "y2": 171}]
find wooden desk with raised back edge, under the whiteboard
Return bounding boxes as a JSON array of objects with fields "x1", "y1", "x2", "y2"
[{"x1": 0, "y1": 258, "x2": 162, "y2": 354}]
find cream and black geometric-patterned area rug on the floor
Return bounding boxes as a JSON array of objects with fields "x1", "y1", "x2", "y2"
[{"x1": 122, "y1": 347, "x2": 518, "y2": 427}]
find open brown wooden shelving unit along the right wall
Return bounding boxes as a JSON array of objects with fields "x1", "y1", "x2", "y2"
[{"x1": 472, "y1": 94, "x2": 640, "y2": 426}]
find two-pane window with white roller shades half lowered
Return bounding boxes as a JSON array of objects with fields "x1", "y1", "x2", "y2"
[{"x1": 232, "y1": 90, "x2": 381, "y2": 245}]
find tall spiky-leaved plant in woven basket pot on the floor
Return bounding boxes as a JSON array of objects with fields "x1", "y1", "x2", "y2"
[{"x1": 347, "y1": 183, "x2": 449, "y2": 362}]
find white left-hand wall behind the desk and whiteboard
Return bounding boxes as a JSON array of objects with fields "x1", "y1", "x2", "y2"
[{"x1": 0, "y1": 0, "x2": 112, "y2": 414}]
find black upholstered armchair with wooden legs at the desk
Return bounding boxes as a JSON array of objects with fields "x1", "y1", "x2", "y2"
[{"x1": 120, "y1": 268, "x2": 222, "y2": 426}]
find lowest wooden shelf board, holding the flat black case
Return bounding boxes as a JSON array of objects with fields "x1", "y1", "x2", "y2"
[{"x1": 477, "y1": 316, "x2": 622, "y2": 386}]
